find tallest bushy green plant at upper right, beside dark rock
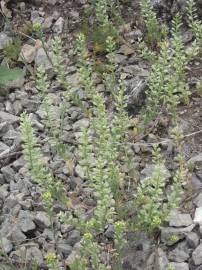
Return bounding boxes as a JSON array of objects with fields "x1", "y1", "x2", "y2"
[{"x1": 143, "y1": 14, "x2": 198, "y2": 123}]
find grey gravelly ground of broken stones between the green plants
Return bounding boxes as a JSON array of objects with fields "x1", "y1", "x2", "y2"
[{"x1": 0, "y1": 0, "x2": 202, "y2": 270}]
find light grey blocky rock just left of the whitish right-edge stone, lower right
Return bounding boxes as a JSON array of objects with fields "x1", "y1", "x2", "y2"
[{"x1": 169, "y1": 211, "x2": 193, "y2": 227}]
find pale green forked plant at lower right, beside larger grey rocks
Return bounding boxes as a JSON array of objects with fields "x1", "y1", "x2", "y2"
[{"x1": 135, "y1": 142, "x2": 186, "y2": 232}]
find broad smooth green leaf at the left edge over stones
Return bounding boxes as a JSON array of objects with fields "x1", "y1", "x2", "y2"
[{"x1": 0, "y1": 67, "x2": 24, "y2": 84}]
